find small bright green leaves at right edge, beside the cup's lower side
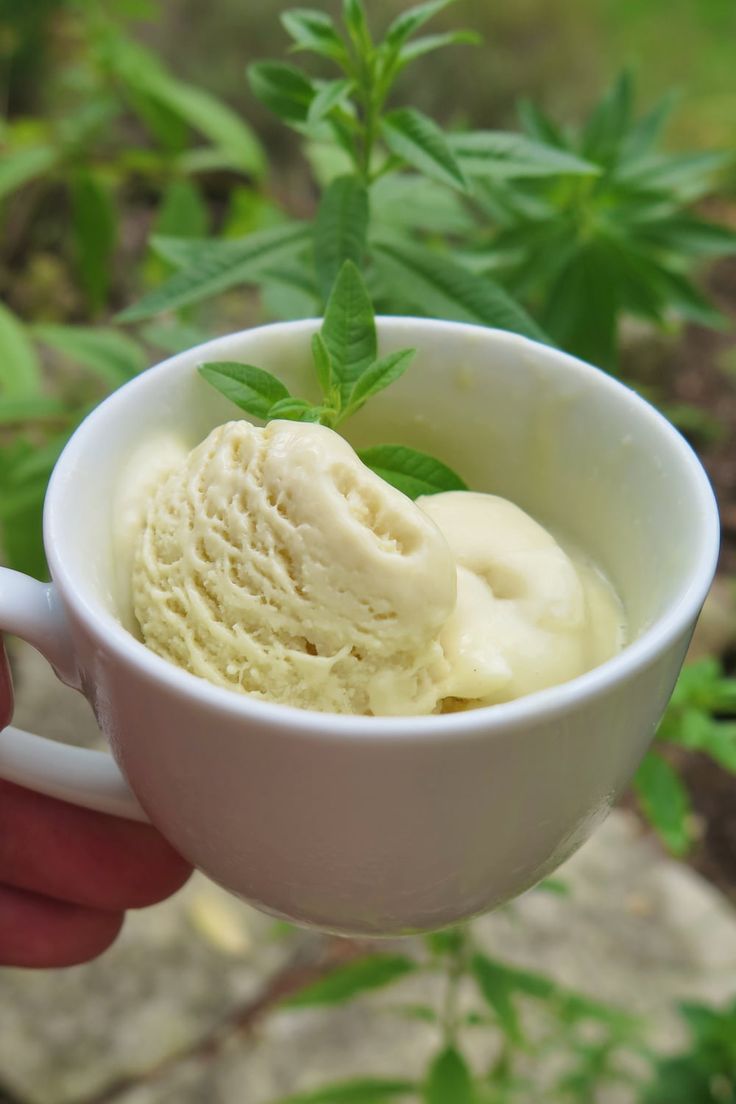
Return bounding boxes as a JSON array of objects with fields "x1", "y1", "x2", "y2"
[{"x1": 634, "y1": 657, "x2": 736, "y2": 856}]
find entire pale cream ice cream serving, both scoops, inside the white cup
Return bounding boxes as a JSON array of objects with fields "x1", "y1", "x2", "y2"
[{"x1": 132, "y1": 421, "x2": 622, "y2": 715}]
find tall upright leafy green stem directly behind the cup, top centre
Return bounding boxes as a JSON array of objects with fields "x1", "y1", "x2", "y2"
[{"x1": 121, "y1": 0, "x2": 596, "y2": 340}]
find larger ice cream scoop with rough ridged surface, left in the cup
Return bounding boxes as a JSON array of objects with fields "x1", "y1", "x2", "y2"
[{"x1": 132, "y1": 421, "x2": 456, "y2": 714}]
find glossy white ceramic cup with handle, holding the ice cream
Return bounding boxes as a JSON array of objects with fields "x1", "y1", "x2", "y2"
[{"x1": 0, "y1": 318, "x2": 718, "y2": 935}]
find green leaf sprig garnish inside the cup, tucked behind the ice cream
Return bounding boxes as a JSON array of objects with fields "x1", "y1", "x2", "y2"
[{"x1": 199, "y1": 261, "x2": 467, "y2": 499}]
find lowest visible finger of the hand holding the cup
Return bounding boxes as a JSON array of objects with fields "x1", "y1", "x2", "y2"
[{"x1": 0, "y1": 885, "x2": 124, "y2": 967}]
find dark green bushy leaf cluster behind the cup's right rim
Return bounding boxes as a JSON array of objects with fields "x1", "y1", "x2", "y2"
[{"x1": 463, "y1": 72, "x2": 736, "y2": 370}]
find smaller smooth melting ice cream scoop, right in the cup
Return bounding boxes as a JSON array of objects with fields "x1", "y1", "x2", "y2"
[{"x1": 417, "y1": 491, "x2": 625, "y2": 709}]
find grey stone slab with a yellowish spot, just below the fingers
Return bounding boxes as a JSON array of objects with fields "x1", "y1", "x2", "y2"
[{"x1": 0, "y1": 877, "x2": 313, "y2": 1104}]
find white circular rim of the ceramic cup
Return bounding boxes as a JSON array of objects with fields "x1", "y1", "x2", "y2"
[{"x1": 43, "y1": 316, "x2": 721, "y2": 741}]
